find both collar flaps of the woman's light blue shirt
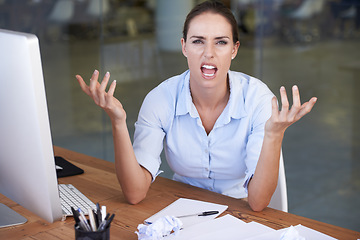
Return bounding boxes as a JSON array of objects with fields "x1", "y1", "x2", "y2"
[{"x1": 175, "y1": 70, "x2": 246, "y2": 122}]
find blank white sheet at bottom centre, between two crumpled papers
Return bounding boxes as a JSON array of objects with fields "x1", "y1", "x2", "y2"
[{"x1": 165, "y1": 214, "x2": 275, "y2": 240}]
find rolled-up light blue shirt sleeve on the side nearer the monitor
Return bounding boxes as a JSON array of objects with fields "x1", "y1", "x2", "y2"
[{"x1": 133, "y1": 81, "x2": 171, "y2": 181}]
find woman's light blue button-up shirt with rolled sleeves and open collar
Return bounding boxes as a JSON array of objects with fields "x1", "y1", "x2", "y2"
[{"x1": 133, "y1": 70, "x2": 274, "y2": 198}]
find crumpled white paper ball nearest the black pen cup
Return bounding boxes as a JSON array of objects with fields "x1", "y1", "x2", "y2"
[{"x1": 135, "y1": 216, "x2": 183, "y2": 240}]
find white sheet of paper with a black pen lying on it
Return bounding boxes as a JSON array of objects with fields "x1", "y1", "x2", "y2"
[{"x1": 145, "y1": 198, "x2": 228, "y2": 229}]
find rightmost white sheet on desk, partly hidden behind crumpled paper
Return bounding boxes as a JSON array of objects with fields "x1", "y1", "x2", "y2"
[{"x1": 246, "y1": 224, "x2": 336, "y2": 240}]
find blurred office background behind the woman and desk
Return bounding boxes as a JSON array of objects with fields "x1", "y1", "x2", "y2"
[{"x1": 0, "y1": 0, "x2": 360, "y2": 231}]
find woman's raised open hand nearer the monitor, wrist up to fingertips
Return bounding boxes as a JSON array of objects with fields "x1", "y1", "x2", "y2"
[{"x1": 76, "y1": 70, "x2": 126, "y2": 123}]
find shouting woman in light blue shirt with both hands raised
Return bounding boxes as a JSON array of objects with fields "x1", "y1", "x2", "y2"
[{"x1": 76, "y1": 2, "x2": 316, "y2": 211}]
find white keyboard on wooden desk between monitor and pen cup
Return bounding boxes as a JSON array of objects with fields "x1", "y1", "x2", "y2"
[{"x1": 59, "y1": 184, "x2": 96, "y2": 216}]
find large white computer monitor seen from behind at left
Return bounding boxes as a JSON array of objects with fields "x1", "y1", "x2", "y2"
[{"x1": 0, "y1": 29, "x2": 62, "y2": 225}]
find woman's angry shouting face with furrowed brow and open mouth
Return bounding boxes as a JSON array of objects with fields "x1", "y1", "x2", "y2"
[{"x1": 181, "y1": 12, "x2": 240, "y2": 90}]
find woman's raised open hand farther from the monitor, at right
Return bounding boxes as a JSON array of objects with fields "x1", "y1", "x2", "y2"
[{"x1": 265, "y1": 85, "x2": 317, "y2": 136}]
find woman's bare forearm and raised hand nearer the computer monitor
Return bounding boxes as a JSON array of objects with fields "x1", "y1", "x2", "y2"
[{"x1": 76, "y1": 70, "x2": 152, "y2": 204}]
